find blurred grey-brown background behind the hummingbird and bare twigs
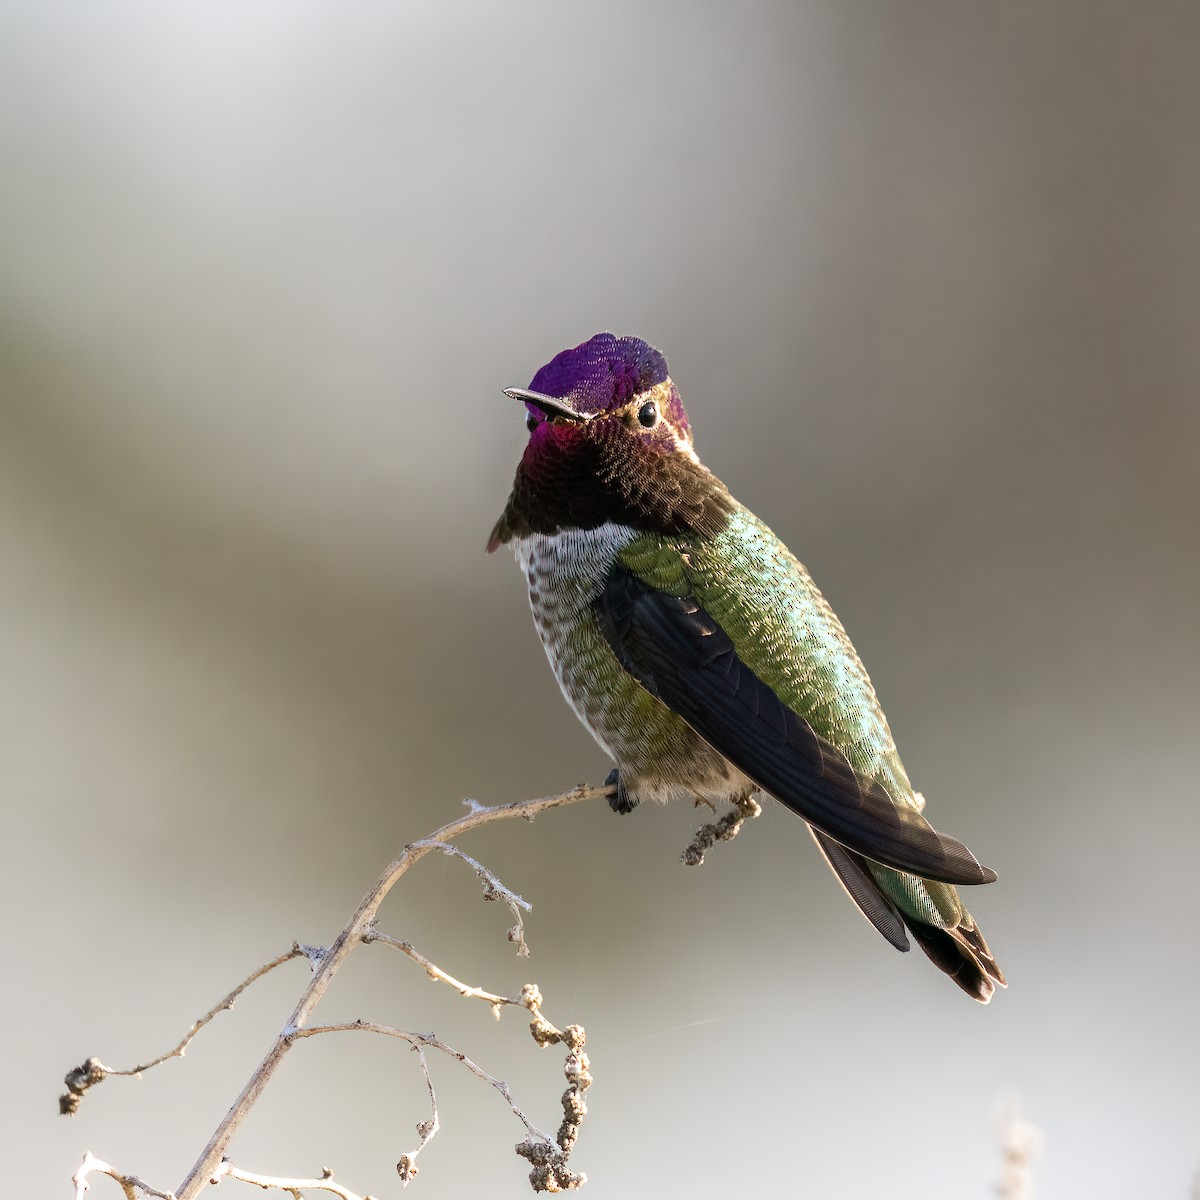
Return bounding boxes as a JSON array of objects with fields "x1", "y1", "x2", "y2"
[{"x1": 0, "y1": 0, "x2": 1200, "y2": 1200}]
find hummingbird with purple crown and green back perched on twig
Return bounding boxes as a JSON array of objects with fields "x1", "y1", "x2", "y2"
[{"x1": 487, "y1": 334, "x2": 1004, "y2": 1003}]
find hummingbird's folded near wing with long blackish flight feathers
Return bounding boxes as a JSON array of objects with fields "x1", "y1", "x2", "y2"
[{"x1": 596, "y1": 565, "x2": 996, "y2": 883}]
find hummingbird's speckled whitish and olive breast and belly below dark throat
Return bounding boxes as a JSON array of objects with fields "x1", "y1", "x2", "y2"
[{"x1": 512, "y1": 523, "x2": 754, "y2": 803}]
